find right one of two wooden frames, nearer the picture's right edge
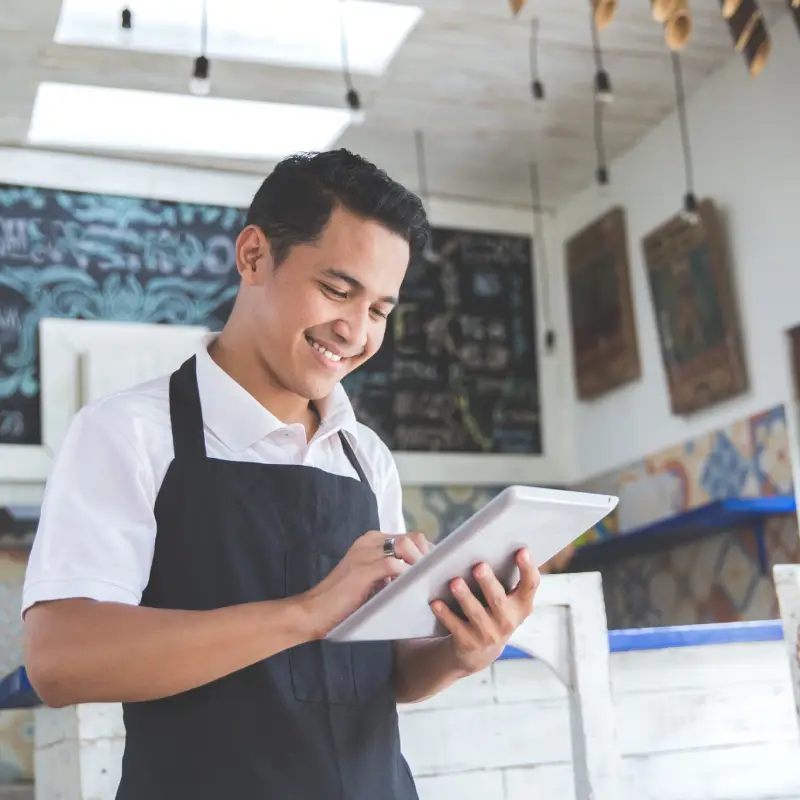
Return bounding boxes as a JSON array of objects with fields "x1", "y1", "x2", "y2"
[{"x1": 642, "y1": 199, "x2": 748, "y2": 416}]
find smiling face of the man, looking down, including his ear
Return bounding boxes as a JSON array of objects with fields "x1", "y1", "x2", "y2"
[{"x1": 238, "y1": 208, "x2": 409, "y2": 400}]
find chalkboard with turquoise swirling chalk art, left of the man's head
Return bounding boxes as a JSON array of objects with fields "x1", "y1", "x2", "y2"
[{"x1": 0, "y1": 184, "x2": 244, "y2": 444}]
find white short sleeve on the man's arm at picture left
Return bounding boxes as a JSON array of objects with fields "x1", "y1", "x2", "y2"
[{"x1": 22, "y1": 401, "x2": 156, "y2": 614}]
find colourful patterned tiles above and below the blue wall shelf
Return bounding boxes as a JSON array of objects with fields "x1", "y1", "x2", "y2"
[{"x1": 578, "y1": 406, "x2": 800, "y2": 628}]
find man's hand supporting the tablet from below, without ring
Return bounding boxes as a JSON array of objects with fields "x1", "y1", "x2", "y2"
[{"x1": 431, "y1": 549, "x2": 540, "y2": 674}]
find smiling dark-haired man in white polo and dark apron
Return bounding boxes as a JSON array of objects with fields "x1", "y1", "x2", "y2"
[{"x1": 23, "y1": 150, "x2": 538, "y2": 800}]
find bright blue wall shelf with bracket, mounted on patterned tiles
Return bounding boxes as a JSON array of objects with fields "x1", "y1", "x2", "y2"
[{"x1": 567, "y1": 495, "x2": 796, "y2": 572}]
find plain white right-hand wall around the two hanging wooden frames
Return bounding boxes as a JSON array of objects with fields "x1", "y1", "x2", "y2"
[{"x1": 557, "y1": 14, "x2": 800, "y2": 477}]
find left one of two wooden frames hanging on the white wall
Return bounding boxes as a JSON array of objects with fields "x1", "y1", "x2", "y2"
[{"x1": 565, "y1": 206, "x2": 641, "y2": 400}]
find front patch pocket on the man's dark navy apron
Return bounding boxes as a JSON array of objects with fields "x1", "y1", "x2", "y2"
[{"x1": 286, "y1": 550, "x2": 359, "y2": 705}]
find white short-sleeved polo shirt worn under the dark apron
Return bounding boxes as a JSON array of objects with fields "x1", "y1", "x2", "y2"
[{"x1": 22, "y1": 334, "x2": 405, "y2": 613}]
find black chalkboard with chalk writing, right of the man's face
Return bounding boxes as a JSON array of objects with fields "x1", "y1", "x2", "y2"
[{"x1": 343, "y1": 228, "x2": 542, "y2": 454}]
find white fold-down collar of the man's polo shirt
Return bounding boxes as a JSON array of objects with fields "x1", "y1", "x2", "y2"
[{"x1": 195, "y1": 333, "x2": 358, "y2": 452}]
